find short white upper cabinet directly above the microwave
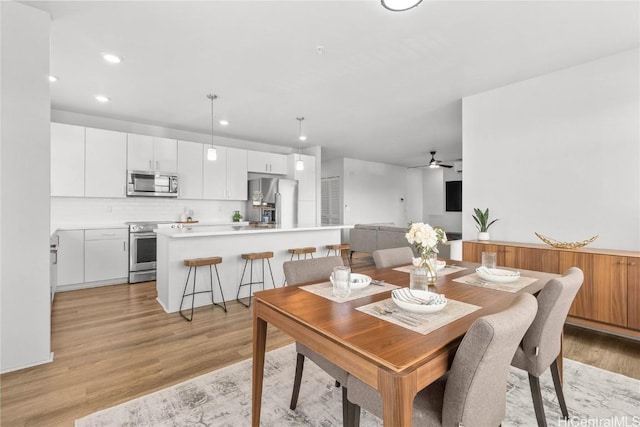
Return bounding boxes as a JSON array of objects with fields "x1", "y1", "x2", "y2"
[{"x1": 127, "y1": 133, "x2": 178, "y2": 172}]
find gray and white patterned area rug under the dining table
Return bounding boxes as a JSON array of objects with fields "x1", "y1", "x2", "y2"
[{"x1": 75, "y1": 344, "x2": 640, "y2": 427}]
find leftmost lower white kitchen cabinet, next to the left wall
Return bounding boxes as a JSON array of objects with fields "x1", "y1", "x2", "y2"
[{"x1": 56, "y1": 230, "x2": 84, "y2": 287}]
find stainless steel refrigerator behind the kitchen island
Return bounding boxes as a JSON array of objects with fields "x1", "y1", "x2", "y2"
[{"x1": 247, "y1": 178, "x2": 298, "y2": 226}]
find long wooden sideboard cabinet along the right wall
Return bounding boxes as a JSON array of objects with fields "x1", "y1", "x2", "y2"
[{"x1": 462, "y1": 241, "x2": 640, "y2": 336}]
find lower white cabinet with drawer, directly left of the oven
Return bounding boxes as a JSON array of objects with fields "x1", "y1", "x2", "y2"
[{"x1": 84, "y1": 228, "x2": 129, "y2": 283}]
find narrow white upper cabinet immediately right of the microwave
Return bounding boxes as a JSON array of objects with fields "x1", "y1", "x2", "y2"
[{"x1": 178, "y1": 141, "x2": 203, "y2": 199}]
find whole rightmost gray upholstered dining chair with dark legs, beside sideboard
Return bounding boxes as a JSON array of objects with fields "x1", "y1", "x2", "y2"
[{"x1": 511, "y1": 267, "x2": 584, "y2": 426}]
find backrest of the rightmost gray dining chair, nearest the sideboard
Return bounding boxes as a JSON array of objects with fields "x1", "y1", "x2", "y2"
[{"x1": 514, "y1": 267, "x2": 584, "y2": 377}]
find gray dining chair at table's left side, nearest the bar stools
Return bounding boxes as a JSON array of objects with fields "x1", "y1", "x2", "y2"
[{"x1": 283, "y1": 256, "x2": 347, "y2": 419}]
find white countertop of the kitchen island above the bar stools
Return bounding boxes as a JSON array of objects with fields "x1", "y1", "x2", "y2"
[{"x1": 154, "y1": 225, "x2": 353, "y2": 238}]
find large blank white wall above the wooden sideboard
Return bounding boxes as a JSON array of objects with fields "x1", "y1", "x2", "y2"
[{"x1": 462, "y1": 49, "x2": 640, "y2": 250}]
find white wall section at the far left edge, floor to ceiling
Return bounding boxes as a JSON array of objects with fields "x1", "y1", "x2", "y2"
[{"x1": 0, "y1": 2, "x2": 51, "y2": 372}]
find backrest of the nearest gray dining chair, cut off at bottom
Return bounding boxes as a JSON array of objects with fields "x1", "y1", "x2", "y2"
[{"x1": 442, "y1": 293, "x2": 538, "y2": 426}]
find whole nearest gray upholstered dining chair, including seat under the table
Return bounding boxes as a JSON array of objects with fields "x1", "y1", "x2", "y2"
[{"x1": 346, "y1": 293, "x2": 538, "y2": 427}]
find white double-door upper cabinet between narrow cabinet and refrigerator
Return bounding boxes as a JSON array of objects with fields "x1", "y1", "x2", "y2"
[{"x1": 202, "y1": 145, "x2": 248, "y2": 200}]
